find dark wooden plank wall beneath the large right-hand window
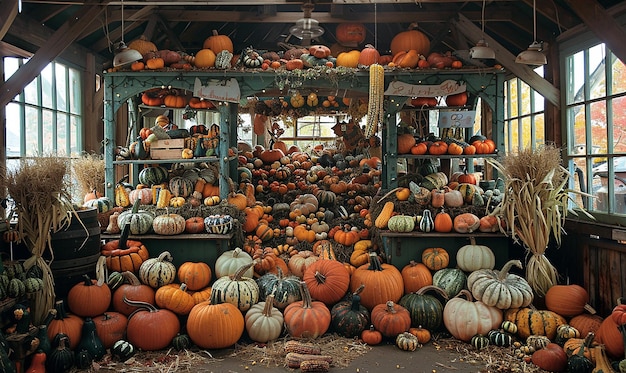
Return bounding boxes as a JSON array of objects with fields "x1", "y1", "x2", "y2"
[{"x1": 557, "y1": 221, "x2": 626, "y2": 317}]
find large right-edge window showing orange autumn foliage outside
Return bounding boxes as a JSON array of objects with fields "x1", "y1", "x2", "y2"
[{"x1": 563, "y1": 43, "x2": 626, "y2": 221}]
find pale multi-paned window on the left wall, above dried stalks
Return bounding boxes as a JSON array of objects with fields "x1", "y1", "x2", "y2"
[{"x1": 3, "y1": 57, "x2": 82, "y2": 167}]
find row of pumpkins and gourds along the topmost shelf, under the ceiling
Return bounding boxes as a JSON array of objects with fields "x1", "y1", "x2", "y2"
[{"x1": 109, "y1": 23, "x2": 470, "y2": 72}]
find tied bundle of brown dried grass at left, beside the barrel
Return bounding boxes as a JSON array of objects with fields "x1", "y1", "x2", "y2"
[{"x1": 1, "y1": 156, "x2": 76, "y2": 323}]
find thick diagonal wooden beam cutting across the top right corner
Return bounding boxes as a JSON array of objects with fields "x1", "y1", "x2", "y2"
[{"x1": 565, "y1": 0, "x2": 626, "y2": 63}]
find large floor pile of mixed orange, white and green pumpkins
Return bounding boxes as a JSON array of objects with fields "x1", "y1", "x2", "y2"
[{"x1": 2, "y1": 227, "x2": 626, "y2": 373}]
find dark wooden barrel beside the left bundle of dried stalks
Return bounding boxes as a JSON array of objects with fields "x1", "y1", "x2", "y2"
[{"x1": 48, "y1": 208, "x2": 100, "y2": 299}]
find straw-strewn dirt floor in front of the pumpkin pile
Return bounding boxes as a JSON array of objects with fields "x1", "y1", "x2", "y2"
[{"x1": 67, "y1": 336, "x2": 540, "y2": 373}]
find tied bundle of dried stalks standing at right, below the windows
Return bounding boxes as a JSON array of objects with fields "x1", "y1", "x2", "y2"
[{"x1": 489, "y1": 145, "x2": 590, "y2": 296}]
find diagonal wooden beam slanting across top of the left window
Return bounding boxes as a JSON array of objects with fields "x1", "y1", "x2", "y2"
[{"x1": 0, "y1": 5, "x2": 106, "y2": 106}]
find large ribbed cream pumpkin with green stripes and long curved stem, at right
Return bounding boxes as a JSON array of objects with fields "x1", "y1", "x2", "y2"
[{"x1": 467, "y1": 260, "x2": 533, "y2": 310}]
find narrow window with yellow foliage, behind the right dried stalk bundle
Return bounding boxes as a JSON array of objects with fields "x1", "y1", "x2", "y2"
[{"x1": 504, "y1": 67, "x2": 545, "y2": 154}]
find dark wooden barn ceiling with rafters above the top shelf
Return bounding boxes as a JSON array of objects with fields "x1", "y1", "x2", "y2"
[{"x1": 0, "y1": 0, "x2": 626, "y2": 67}]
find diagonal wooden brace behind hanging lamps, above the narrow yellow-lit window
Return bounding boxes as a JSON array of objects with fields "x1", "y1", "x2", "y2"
[{"x1": 452, "y1": 14, "x2": 561, "y2": 108}]
